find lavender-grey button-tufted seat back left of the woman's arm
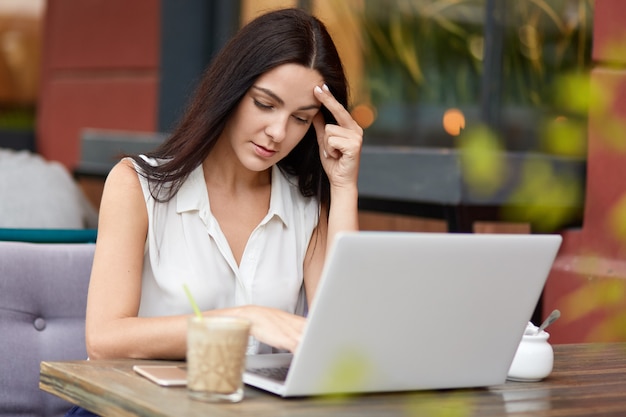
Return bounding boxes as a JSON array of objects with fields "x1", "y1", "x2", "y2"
[{"x1": 0, "y1": 242, "x2": 95, "y2": 417}]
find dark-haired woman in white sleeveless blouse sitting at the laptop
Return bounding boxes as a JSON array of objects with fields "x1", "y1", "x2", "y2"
[{"x1": 86, "y1": 9, "x2": 363, "y2": 359}]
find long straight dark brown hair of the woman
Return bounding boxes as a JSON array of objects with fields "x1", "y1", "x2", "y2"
[{"x1": 133, "y1": 9, "x2": 348, "y2": 211}]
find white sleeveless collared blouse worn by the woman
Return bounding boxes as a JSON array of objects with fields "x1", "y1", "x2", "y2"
[{"x1": 132, "y1": 159, "x2": 319, "y2": 353}]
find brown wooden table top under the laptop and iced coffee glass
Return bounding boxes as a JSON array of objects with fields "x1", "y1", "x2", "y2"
[{"x1": 40, "y1": 343, "x2": 626, "y2": 417}]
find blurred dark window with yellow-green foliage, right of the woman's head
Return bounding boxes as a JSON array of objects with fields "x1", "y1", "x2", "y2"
[{"x1": 355, "y1": 0, "x2": 593, "y2": 156}]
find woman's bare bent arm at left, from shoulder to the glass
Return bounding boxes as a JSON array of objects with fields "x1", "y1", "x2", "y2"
[{"x1": 86, "y1": 160, "x2": 185, "y2": 359}]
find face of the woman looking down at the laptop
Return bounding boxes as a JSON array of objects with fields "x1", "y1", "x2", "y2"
[{"x1": 220, "y1": 64, "x2": 324, "y2": 171}]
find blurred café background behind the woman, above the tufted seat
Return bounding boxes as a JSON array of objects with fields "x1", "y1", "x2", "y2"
[{"x1": 0, "y1": 0, "x2": 626, "y2": 414}]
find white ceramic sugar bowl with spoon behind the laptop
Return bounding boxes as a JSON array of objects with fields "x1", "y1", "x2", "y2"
[{"x1": 507, "y1": 323, "x2": 554, "y2": 381}]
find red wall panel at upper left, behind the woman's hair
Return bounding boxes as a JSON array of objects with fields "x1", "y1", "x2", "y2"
[{"x1": 37, "y1": 0, "x2": 160, "y2": 170}]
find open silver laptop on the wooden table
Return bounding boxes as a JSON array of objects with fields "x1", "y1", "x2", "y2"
[{"x1": 244, "y1": 231, "x2": 561, "y2": 397}]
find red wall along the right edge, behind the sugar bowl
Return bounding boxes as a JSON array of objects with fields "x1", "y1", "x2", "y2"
[{"x1": 544, "y1": 0, "x2": 626, "y2": 343}]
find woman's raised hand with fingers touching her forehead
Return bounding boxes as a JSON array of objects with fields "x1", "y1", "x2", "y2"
[{"x1": 313, "y1": 85, "x2": 363, "y2": 187}]
